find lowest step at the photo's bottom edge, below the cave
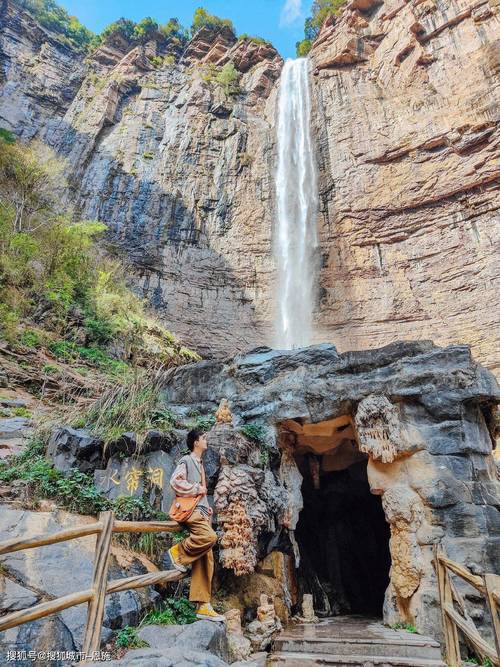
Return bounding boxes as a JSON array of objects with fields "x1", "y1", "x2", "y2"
[{"x1": 267, "y1": 651, "x2": 446, "y2": 667}]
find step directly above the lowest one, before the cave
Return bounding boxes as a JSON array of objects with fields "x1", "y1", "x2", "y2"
[{"x1": 274, "y1": 635, "x2": 441, "y2": 660}]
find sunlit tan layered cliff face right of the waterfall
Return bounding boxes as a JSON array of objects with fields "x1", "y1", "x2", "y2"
[{"x1": 311, "y1": 0, "x2": 500, "y2": 367}]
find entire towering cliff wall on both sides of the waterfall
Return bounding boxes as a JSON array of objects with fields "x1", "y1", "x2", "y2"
[{"x1": 0, "y1": 0, "x2": 500, "y2": 368}]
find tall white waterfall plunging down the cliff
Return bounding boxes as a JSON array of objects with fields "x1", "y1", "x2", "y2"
[{"x1": 275, "y1": 58, "x2": 318, "y2": 349}]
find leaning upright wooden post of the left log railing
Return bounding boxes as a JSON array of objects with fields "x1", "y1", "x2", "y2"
[{"x1": 83, "y1": 512, "x2": 114, "y2": 659}]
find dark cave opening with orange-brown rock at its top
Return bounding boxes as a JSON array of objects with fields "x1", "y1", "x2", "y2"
[{"x1": 283, "y1": 416, "x2": 391, "y2": 617}]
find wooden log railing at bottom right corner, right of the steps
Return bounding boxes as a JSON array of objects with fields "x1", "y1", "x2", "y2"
[{"x1": 434, "y1": 547, "x2": 500, "y2": 667}]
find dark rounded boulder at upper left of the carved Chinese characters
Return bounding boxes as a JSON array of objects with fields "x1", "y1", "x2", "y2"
[{"x1": 47, "y1": 426, "x2": 103, "y2": 473}]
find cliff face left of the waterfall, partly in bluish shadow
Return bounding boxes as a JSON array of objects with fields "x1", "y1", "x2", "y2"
[{"x1": 0, "y1": 2, "x2": 282, "y2": 354}]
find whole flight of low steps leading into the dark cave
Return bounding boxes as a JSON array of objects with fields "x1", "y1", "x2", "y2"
[{"x1": 268, "y1": 616, "x2": 446, "y2": 667}]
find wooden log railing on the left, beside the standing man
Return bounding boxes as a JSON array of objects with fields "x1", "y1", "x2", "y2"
[{"x1": 0, "y1": 512, "x2": 182, "y2": 656}]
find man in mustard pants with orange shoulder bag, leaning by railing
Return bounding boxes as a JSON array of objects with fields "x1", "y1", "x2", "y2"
[{"x1": 163, "y1": 429, "x2": 225, "y2": 621}]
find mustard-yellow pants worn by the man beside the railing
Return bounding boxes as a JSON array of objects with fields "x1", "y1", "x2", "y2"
[{"x1": 176, "y1": 510, "x2": 217, "y2": 602}]
